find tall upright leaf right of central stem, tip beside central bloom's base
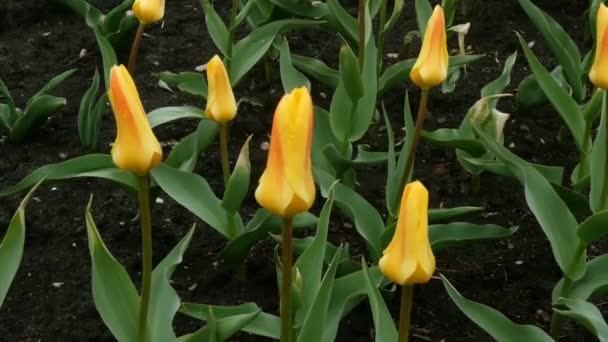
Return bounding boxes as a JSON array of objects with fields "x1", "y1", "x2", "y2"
[{"x1": 294, "y1": 189, "x2": 334, "y2": 324}]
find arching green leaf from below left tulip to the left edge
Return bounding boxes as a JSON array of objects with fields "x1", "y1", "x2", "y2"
[{"x1": 0, "y1": 154, "x2": 137, "y2": 197}]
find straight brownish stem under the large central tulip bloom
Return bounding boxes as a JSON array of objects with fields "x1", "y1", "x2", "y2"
[{"x1": 280, "y1": 217, "x2": 293, "y2": 342}]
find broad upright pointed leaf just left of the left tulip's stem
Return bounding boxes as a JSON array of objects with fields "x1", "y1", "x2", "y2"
[{"x1": 85, "y1": 197, "x2": 139, "y2": 342}]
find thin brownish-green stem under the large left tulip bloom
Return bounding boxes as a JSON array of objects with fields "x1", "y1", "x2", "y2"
[{"x1": 138, "y1": 175, "x2": 152, "y2": 342}]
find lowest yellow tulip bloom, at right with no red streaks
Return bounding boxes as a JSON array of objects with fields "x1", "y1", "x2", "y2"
[{"x1": 378, "y1": 181, "x2": 435, "y2": 285}]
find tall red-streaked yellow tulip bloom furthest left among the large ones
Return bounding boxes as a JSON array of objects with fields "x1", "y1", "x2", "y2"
[{"x1": 108, "y1": 65, "x2": 163, "y2": 175}]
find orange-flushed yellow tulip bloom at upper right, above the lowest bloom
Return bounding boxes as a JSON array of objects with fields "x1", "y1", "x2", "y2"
[{"x1": 410, "y1": 5, "x2": 449, "y2": 90}]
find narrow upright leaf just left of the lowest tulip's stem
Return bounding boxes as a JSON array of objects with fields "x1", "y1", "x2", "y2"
[{"x1": 361, "y1": 260, "x2": 399, "y2": 341}]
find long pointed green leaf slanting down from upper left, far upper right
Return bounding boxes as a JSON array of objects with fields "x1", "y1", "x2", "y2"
[{"x1": 517, "y1": 32, "x2": 585, "y2": 152}]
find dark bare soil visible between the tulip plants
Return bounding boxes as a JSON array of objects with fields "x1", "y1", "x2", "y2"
[{"x1": 0, "y1": 0, "x2": 607, "y2": 342}]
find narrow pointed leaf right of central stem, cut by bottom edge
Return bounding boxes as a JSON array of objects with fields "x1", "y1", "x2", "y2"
[{"x1": 297, "y1": 246, "x2": 343, "y2": 342}]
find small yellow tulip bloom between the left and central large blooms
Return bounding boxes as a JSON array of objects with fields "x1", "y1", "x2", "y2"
[{"x1": 205, "y1": 55, "x2": 237, "y2": 123}]
